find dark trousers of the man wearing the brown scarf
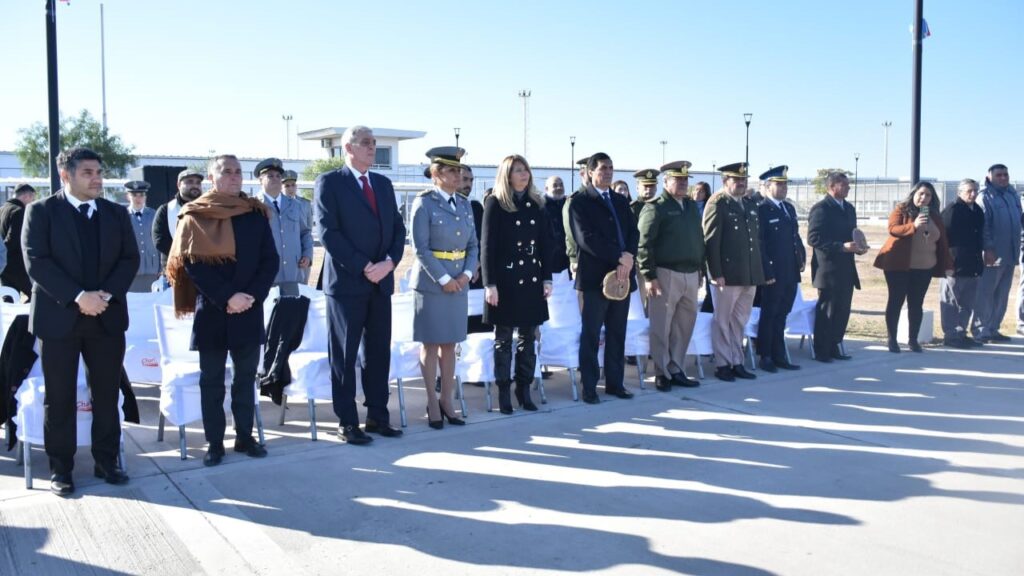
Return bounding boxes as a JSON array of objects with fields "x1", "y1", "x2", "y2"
[{"x1": 199, "y1": 344, "x2": 259, "y2": 446}]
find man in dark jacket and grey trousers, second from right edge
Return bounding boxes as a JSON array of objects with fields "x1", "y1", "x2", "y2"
[{"x1": 939, "y1": 178, "x2": 985, "y2": 348}]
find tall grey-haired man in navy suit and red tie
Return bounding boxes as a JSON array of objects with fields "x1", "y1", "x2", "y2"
[{"x1": 313, "y1": 126, "x2": 406, "y2": 445}]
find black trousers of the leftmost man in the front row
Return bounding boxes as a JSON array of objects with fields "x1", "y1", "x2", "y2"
[{"x1": 39, "y1": 316, "x2": 125, "y2": 474}]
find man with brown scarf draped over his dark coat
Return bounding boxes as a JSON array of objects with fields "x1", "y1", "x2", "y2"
[{"x1": 167, "y1": 154, "x2": 279, "y2": 466}]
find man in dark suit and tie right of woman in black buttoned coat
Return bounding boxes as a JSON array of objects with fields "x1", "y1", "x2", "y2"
[{"x1": 568, "y1": 152, "x2": 640, "y2": 404}]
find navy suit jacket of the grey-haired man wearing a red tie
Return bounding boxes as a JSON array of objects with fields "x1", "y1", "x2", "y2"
[{"x1": 313, "y1": 166, "x2": 406, "y2": 296}]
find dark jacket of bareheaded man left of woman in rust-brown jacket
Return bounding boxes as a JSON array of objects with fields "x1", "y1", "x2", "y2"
[{"x1": 807, "y1": 196, "x2": 860, "y2": 290}]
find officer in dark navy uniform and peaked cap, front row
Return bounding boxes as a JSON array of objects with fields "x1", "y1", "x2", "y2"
[{"x1": 758, "y1": 165, "x2": 807, "y2": 372}]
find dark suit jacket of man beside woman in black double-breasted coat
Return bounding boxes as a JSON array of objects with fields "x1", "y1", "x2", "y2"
[{"x1": 569, "y1": 188, "x2": 640, "y2": 291}]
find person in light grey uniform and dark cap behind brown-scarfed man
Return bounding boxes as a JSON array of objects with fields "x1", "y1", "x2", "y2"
[{"x1": 253, "y1": 158, "x2": 313, "y2": 294}]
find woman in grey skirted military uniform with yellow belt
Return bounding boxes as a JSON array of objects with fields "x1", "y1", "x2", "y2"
[{"x1": 410, "y1": 147, "x2": 478, "y2": 428}]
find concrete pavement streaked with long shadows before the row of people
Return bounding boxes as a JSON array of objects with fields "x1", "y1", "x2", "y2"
[{"x1": 0, "y1": 338, "x2": 1024, "y2": 576}]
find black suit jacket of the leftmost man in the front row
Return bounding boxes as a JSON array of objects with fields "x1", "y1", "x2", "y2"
[{"x1": 22, "y1": 190, "x2": 138, "y2": 339}]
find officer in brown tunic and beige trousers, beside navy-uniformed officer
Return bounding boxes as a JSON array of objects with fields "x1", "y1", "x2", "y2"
[{"x1": 703, "y1": 162, "x2": 765, "y2": 382}]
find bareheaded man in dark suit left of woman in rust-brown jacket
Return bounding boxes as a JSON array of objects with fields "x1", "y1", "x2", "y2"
[{"x1": 807, "y1": 172, "x2": 867, "y2": 363}]
